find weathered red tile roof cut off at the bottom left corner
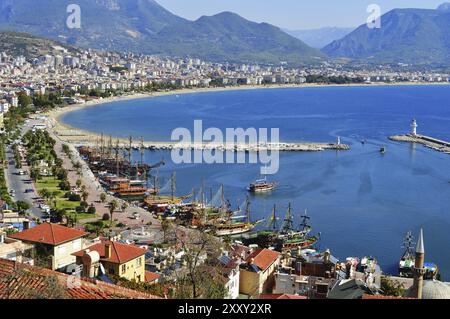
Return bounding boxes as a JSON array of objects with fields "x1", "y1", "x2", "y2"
[{"x1": 0, "y1": 259, "x2": 160, "y2": 299}]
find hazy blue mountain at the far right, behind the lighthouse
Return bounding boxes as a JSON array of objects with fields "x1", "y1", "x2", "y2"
[{"x1": 323, "y1": 3, "x2": 450, "y2": 64}]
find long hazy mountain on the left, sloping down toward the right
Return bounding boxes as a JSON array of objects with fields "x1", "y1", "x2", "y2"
[{"x1": 0, "y1": 0, "x2": 324, "y2": 64}]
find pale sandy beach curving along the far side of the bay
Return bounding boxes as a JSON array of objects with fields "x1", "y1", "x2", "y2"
[{"x1": 43, "y1": 82, "x2": 450, "y2": 151}]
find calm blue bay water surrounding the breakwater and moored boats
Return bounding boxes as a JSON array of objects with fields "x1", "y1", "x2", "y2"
[{"x1": 56, "y1": 86, "x2": 450, "y2": 278}]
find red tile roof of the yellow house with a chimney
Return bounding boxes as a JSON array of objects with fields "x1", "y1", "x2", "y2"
[{"x1": 73, "y1": 240, "x2": 147, "y2": 264}]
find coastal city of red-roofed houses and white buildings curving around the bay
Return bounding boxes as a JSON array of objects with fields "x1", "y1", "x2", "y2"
[{"x1": 0, "y1": 48, "x2": 450, "y2": 299}]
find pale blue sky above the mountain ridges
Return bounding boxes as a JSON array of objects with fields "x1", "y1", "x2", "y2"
[{"x1": 156, "y1": 0, "x2": 448, "y2": 30}]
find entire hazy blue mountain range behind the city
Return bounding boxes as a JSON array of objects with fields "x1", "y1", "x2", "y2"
[{"x1": 0, "y1": 0, "x2": 450, "y2": 65}]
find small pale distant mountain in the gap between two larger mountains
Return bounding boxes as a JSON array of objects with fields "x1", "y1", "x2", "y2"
[{"x1": 284, "y1": 27, "x2": 355, "y2": 49}]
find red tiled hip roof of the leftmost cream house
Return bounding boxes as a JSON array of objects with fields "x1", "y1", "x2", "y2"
[{"x1": 10, "y1": 223, "x2": 87, "y2": 246}]
